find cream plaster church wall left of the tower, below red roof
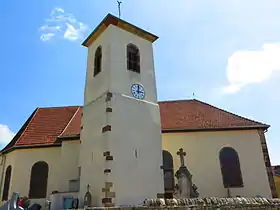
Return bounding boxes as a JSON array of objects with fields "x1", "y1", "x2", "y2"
[{"x1": 1, "y1": 141, "x2": 79, "y2": 206}]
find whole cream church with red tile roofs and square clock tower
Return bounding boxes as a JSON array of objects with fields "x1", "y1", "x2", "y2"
[{"x1": 0, "y1": 14, "x2": 277, "y2": 206}]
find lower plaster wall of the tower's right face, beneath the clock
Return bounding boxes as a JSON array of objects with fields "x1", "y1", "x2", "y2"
[{"x1": 108, "y1": 95, "x2": 164, "y2": 205}]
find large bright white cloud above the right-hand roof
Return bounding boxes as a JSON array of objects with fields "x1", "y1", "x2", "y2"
[{"x1": 223, "y1": 43, "x2": 280, "y2": 93}]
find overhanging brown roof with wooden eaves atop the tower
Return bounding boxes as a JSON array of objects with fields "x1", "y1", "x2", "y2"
[{"x1": 82, "y1": 14, "x2": 158, "y2": 47}]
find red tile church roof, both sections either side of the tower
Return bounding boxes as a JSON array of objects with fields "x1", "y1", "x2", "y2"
[{"x1": 2, "y1": 100, "x2": 269, "y2": 151}]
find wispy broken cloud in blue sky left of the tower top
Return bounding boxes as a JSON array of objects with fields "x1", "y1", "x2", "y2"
[{"x1": 39, "y1": 8, "x2": 88, "y2": 41}]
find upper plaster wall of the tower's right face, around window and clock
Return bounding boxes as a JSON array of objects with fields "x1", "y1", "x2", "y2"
[{"x1": 107, "y1": 25, "x2": 157, "y2": 103}]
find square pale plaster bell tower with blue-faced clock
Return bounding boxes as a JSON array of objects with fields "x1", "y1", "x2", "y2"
[{"x1": 80, "y1": 14, "x2": 164, "y2": 206}]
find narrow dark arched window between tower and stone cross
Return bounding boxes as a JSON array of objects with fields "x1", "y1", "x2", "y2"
[{"x1": 162, "y1": 150, "x2": 174, "y2": 192}]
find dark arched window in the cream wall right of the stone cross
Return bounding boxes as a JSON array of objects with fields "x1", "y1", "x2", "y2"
[{"x1": 220, "y1": 147, "x2": 243, "y2": 188}]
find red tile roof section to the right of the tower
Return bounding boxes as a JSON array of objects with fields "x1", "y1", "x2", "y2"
[{"x1": 159, "y1": 100, "x2": 269, "y2": 130}]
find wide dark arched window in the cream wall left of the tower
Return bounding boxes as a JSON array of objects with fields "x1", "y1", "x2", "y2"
[{"x1": 29, "y1": 161, "x2": 49, "y2": 198}]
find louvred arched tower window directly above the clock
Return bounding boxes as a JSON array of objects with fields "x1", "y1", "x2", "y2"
[{"x1": 126, "y1": 44, "x2": 140, "y2": 73}]
